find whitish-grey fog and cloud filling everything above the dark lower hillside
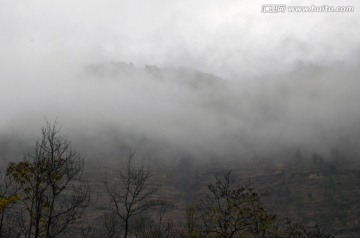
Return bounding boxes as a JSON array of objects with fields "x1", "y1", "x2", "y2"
[{"x1": 0, "y1": 0, "x2": 360, "y2": 165}]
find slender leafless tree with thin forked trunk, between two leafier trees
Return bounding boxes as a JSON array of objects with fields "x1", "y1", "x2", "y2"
[{"x1": 102, "y1": 150, "x2": 162, "y2": 238}]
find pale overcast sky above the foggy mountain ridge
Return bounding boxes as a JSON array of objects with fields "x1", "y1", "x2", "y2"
[{"x1": 0, "y1": 0, "x2": 360, "y2": 77}]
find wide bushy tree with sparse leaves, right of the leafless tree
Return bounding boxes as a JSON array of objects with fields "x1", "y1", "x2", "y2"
[{"x1": 198, "y1": 172, "x2": 275, "y2": 238}]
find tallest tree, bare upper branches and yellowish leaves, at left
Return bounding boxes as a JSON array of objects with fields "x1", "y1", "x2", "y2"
[{"x1": 7, "y1": 122, "x2": 89, "y2": 238}]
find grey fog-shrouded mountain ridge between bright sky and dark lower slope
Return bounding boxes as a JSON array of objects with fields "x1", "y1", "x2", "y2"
[{"x1": 1, "y1": 62, "x2": 360, "y2": 166}]
